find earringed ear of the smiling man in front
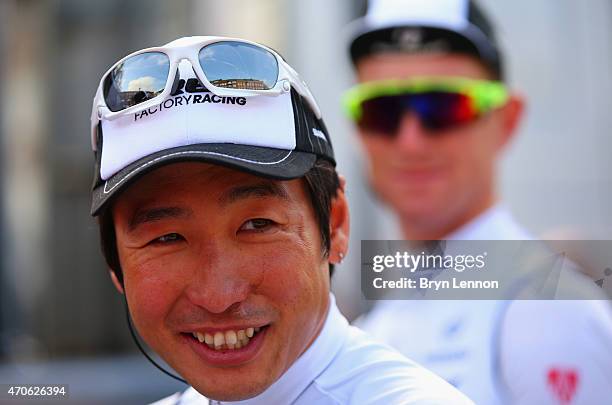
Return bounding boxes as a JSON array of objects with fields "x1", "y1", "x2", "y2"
[{"x1": 329, "y1": 175, "x2": 350, "y2": 264}]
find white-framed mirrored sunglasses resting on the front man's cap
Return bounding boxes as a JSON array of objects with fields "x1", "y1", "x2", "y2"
[{"x1": 92, "y1": 36, "x2": 321, "y2": 150}]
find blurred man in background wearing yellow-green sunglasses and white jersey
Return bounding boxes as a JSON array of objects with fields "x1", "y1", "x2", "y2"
[{"x1": 345, "y1": 0, "x2": 612, "y2": 404}]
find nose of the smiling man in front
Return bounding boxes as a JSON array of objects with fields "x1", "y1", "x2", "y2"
[{"x1": 185, "y1": 246, "x2": 257, "y2": 314}]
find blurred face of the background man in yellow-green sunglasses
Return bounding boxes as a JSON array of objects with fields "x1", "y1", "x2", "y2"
[{"x1": 357, "y1": 53, "x2": 514, "y2": 239}]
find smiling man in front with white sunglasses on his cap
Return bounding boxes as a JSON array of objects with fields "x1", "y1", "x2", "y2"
[{"x1": 92, "y1": 37, "x2": 471, "y2": 404}]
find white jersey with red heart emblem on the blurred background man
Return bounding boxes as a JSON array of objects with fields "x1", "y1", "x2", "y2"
[{"x1": 356, "y1": 206, "x2": 612, "y2": 405}]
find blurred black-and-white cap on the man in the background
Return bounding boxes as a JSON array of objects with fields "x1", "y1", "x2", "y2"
[{"x1": 347, "y1": 0, "x2": 503, "y2": 79}]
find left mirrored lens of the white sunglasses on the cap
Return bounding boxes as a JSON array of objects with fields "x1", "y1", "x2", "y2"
[{"x1": 104, "y1": 52, "x2": 170, "y2": 111}]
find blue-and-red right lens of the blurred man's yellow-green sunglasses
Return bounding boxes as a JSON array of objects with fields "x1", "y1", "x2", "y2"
[{"x1": 410, "y1": 92, "x2": 478, "y2": 131}]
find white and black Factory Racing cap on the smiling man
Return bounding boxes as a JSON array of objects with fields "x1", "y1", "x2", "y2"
[{"x1": 91, "y1": 37, "x2": 335, "y2": 216}]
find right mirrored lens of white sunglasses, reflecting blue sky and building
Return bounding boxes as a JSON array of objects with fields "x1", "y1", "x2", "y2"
[{"x1": 199, "y1": 41, "x2": 278, "y2": 90}]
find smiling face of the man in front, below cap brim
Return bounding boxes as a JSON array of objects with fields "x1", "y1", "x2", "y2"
[{"x1": 113, "y1": 163, "x2": 338, "y2": 400}]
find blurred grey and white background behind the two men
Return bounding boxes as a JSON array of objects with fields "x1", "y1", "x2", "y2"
[{"x1": 0, "y1": 0, "x2": 612, "y2": 403}]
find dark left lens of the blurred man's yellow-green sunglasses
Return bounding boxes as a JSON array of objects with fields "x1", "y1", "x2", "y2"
[{"x1": 357, "y1": 96, "x2": 407, "y2": 136}]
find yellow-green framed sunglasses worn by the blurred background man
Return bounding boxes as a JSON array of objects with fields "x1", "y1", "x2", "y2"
[{"x1": 343, "y1": 77, "x2": 508, "y2": 136}]
